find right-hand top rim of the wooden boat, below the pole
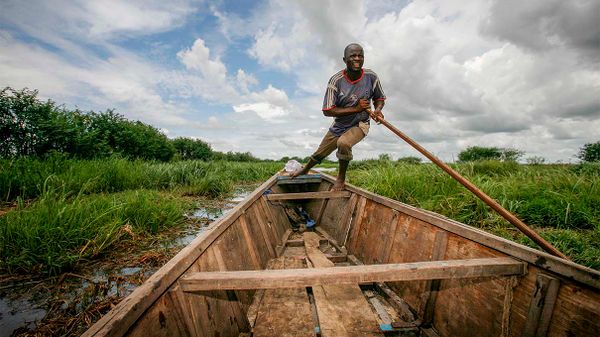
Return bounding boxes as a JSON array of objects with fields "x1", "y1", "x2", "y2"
[{"x1": 319, "y1": 172, "x2": 600, "y2": 290}]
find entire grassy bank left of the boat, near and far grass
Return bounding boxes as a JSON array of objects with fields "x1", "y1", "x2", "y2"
[{"x1": 0, "y1": 157, "x2": 281, "y2": 274}]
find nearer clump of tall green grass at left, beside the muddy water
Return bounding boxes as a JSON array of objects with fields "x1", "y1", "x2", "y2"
[{"x1": 0, "y1": 189, "x2": 189, "y2": 274}]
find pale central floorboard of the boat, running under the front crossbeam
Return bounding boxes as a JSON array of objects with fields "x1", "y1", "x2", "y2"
[{"x1": 303, "y1": 232, "x2": 383, "y2": 337}]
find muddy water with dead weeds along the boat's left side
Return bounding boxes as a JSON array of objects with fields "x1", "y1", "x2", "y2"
[{"x1": 0, "y1": 186, "x2": 255, "y2": 337}]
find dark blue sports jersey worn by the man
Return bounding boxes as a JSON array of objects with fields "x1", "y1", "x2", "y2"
[{"x1": 323, "y1": 69, "x2": 385, "y2": 136}]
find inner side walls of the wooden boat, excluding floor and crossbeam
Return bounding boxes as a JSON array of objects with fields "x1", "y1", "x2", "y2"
[{"x1": 84, "y1": 174, "x2": 600, "y2": 337}]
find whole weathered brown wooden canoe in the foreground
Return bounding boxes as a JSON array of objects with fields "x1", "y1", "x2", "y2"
[{"x1": 84, "y1": 174, "x2": 600, "y2": 337}]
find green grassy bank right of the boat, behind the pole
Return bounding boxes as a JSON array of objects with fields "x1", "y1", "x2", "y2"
[{"x1": 349, "y1": 161, "x2": 600, "y2": 269}]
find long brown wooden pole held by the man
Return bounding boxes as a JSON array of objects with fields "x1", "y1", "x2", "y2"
[{"x1": 369, "y1": 110, "x2": 568, "y2": 260}]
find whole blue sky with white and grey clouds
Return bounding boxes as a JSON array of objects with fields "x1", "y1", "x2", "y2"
[{"x1": 0, "y1": 0, "x2": 600, "y2": 162}]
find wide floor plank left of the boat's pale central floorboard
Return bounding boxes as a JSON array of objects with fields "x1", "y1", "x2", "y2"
[{"x1": 252, "y1": 257, "x2": 315, "y2": 337}]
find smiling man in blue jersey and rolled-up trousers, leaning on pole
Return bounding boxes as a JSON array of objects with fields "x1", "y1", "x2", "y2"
[{"x1": 291, "y1": 43, "x2": 385, "y2": 191}]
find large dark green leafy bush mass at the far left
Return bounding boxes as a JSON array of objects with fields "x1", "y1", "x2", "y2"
[{"x1": 0, "y1": 87, "x2": 175, "y2": 161}]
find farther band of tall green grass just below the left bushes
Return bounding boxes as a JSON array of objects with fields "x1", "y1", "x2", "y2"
[{"x1": 0, "y1": 155, "x2": 282, "y2": 201}]
